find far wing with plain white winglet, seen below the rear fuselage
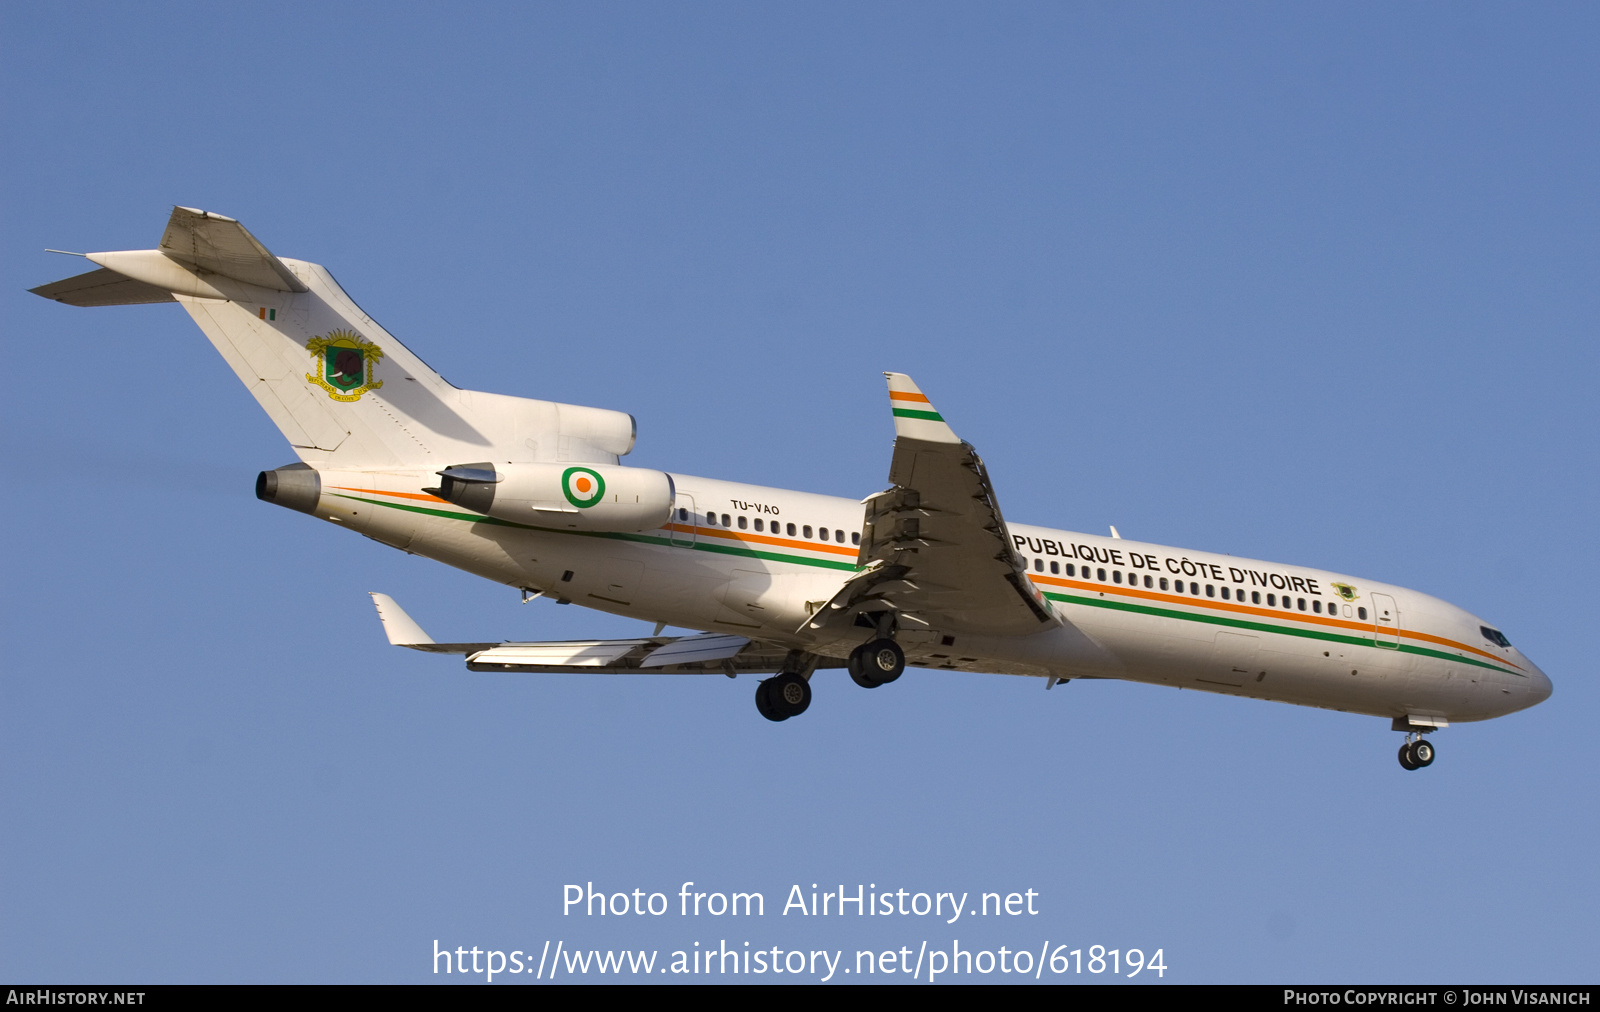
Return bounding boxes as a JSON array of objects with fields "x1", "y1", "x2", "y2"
[{"x1": 373, "y1": 594, "x2": 843, "y2": 677}]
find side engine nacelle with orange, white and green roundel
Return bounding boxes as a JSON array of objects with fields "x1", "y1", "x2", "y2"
[{"x1": 426, "y1": 463, "x2": 677, "y2": 532}]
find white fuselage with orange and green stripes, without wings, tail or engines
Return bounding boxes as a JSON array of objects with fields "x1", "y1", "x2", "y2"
[{"x1": 315, "y1": 471, "x2": 1550, "y2": 724}]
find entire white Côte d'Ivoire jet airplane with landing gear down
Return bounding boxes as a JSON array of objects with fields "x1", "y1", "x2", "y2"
[{"x1": 32, "y1": 207, "x2": 1550, "y2": 770}]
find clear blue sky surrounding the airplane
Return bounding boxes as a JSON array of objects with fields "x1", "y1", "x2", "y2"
[{"x1": 0, "y1": 3, "x2": 1600, "y2": 983}]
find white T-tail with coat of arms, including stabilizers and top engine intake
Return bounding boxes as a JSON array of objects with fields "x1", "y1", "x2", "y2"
[{"x1": 34, "y1": 207, "x2": 634, "y2": 469}]
